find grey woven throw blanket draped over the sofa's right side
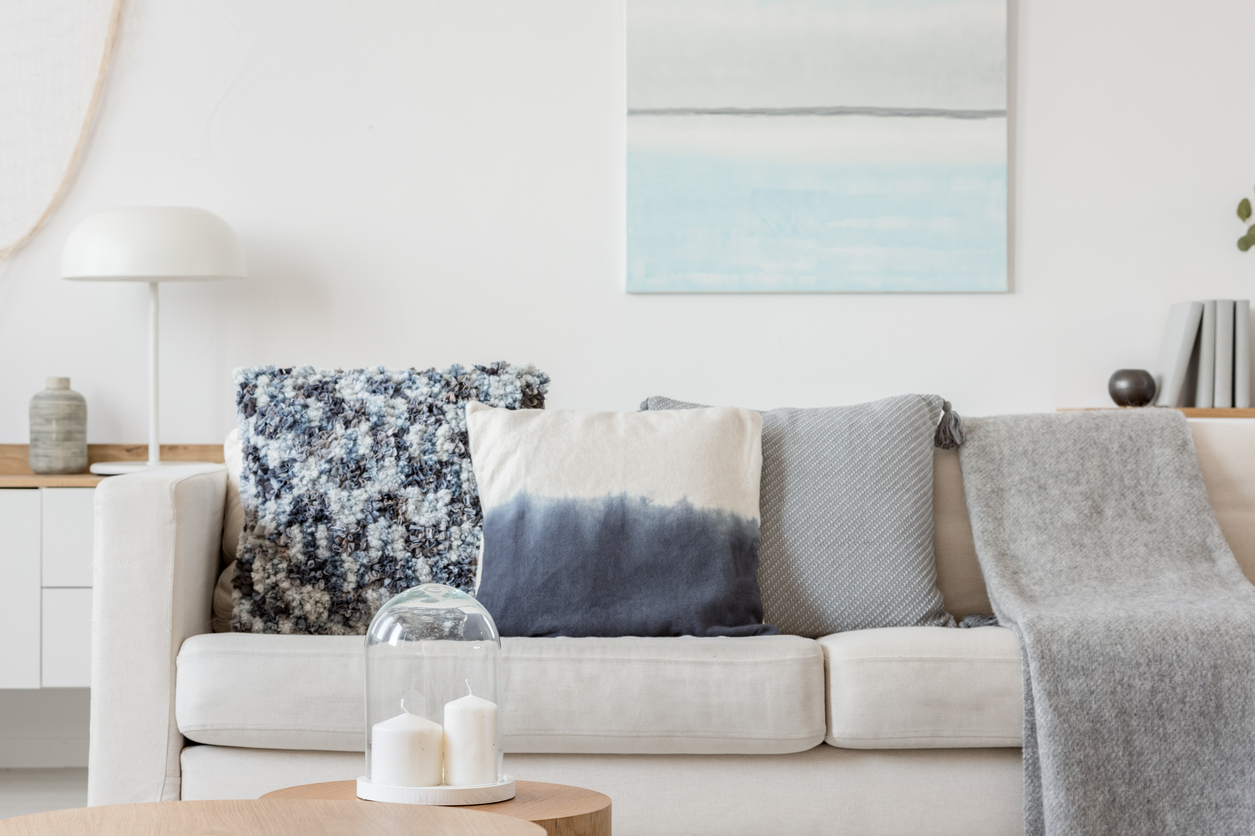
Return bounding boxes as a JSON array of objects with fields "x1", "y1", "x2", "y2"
[{"x1": 959, "y1": 408, "x2": 1255, "y2": 836}]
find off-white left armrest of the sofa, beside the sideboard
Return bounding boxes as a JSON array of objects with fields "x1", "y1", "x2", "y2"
[{"x1": 88, "y1": 464, "x2": 227, "y2": 806}]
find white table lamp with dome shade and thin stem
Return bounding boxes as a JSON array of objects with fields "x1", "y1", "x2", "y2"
[{"x1": 61, "y1": 206, "x2": 247, "y2": 476}]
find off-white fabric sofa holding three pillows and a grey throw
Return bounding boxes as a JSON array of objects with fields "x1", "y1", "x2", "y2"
[{"x1": 89, "y1": 419, "x2": 1255, "y2": 836}]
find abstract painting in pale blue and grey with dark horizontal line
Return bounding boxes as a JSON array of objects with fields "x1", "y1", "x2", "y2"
[{"x1": 626, "y1": 0, "x2": 1008, "y2": 292}]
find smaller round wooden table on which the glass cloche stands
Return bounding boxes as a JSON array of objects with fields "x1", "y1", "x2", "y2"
[{"x1": 262, "y1": 781, "x2": 610, "y2": 836}]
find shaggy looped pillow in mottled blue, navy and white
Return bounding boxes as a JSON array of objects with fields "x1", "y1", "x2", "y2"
[{"x1": 231, "y1": 363, "x2": 548, "y2": 635}]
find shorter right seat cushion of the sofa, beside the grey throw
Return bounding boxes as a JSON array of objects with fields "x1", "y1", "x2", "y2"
[{"x1": 820, "y1": 626, "x2": 1024, "y2": 749}]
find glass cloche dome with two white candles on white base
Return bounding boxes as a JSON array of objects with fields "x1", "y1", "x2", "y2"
[{"x1": 358, "y1": 584, "x2": 515, "y2": 805}]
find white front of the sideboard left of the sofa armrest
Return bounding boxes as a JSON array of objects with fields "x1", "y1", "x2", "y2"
[{"x1": 0, "y1": 487, "x2": 95, "y2": 688}]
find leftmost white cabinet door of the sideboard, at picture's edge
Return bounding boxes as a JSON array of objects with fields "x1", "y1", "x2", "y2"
[{"x1": 0, "y1": 488, "x2": 39, "y2": 688}]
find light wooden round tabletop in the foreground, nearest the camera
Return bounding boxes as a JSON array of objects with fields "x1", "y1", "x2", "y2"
[{"x1": 0, "y1": 800, "x2": 545, "y2": 836}]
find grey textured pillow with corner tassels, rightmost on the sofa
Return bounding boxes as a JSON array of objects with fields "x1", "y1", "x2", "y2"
[{"x1": 641, "y1": 395, "x2": 961, "y2": 638}]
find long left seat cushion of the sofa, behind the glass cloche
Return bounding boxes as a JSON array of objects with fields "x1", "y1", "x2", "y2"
[{"x1": 174, "y1": 633, "x2": 827, "y2": 754}]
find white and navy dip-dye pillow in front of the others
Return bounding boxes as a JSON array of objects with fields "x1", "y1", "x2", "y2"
[{"x1": 467, "y1": 404, "x2": 776, "y2": 636}]
